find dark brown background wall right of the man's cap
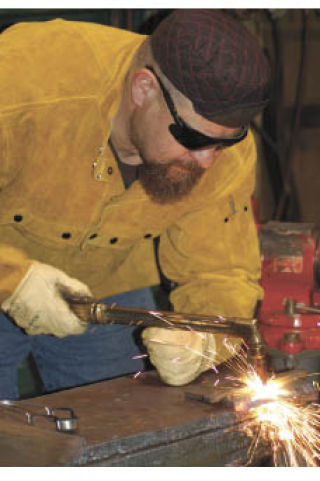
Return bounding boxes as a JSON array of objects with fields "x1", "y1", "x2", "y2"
[{"x1": 238, "y1": 9, "x2": 320, "y2": 227}]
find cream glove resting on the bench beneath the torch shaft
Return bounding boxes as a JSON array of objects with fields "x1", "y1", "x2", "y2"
[{"x1": 142, "y1": 327, "x2": 242, "y2": 386}]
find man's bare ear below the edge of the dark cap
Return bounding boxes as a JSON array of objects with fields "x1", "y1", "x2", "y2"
[{"x1": 131, "y1": 68, "x2": 157, "y2": 107}]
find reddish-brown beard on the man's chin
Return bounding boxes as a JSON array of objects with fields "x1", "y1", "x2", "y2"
[{"x1": 139, "y1": 158, "x2": 205, "y2": 204}]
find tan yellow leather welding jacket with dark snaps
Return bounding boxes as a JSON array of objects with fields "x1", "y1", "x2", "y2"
[{"x1": 0, "y1": 20, "x2": 262, "y2": 316}]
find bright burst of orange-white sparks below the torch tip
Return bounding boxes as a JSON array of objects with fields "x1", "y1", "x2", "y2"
[{"x1": 230, "y1": 356, "x2": 320, "y2": 467}]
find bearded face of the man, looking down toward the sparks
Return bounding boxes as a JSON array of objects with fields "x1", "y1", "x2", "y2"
[{"x1": 131, "y1": 67, "x2": 246, "y2": 203}]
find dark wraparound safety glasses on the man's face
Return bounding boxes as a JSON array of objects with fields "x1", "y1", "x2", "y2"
[{"x1": 145, "y1": 65, "x2": 248, "y2": 150}]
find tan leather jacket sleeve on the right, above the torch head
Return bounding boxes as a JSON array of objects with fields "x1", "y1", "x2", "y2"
[{"x1": 160, "y1": 131, "x2": 263, "y2": 317}]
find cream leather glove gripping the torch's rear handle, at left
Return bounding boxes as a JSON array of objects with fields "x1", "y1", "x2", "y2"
[{"x1": 1, "y1": 261, "x2": 92, "y2": 337}]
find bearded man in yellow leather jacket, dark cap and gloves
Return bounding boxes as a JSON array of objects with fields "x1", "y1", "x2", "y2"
[{"x1": 0, "y1": 10, "x2": 269, "y2": 398}]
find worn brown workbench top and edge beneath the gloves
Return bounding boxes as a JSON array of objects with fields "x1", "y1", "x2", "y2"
[{"x1": 0, "y1": 371, "x2": 266, "y2": 467}]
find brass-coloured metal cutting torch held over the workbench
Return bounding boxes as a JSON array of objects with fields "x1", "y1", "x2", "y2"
[{"x1": 70, "y1": 299, "x2": 267, "y2": 382}]
